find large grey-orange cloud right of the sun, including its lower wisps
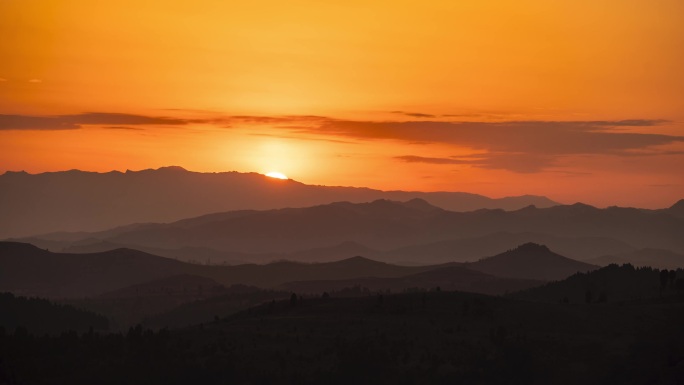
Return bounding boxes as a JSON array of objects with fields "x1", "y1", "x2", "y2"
[{"x1": 368, "y1": 120, "x2": 684, "y2": 173}]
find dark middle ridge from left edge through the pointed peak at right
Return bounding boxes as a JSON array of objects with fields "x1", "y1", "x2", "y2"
[{"x1": 0, "y1": 242, "x2": 597, "y2": 298}]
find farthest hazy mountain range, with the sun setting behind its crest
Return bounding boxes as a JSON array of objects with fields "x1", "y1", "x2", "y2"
[{"x1": 0, "y1": 167, "x2": 556, "y2": 238}]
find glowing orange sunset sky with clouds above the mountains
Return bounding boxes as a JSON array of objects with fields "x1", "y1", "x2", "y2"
[{"x1": 0, "y1": 0, "x2": 684, "y2": 208}]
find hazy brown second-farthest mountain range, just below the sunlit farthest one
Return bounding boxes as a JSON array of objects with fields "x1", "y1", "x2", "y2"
[{"x1": 19, "y1": 200, "x2": 684, "y2": 258}]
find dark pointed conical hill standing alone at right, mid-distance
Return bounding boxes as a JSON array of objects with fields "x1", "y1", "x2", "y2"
[{"x1": 464, "y1": 243, "x2": 598, "y2": 281}]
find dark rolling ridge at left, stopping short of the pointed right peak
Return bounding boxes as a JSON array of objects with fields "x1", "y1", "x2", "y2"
[{"x1": 0, "y1": 242, "x2": 444, "y2": 298}]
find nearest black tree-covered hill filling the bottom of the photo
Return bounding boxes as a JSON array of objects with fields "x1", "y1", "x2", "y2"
[{"x1": 0, "y1": 292, "x2": 684, "y2": 385}]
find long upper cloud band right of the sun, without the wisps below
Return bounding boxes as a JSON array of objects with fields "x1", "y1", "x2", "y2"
[{"x1": 314, "y1": 120, "x2": 684, "y2": 155}]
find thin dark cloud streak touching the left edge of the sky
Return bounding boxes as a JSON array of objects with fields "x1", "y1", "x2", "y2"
[{"x1": 0, "y1": 112, "x2": 194, "y2": 130}]
